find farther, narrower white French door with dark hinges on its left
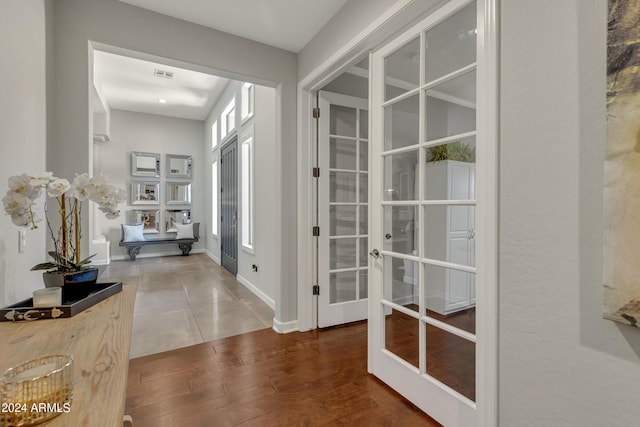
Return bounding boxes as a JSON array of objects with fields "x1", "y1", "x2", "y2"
[{"x1": 318, "y1": 91, "x2": 369, "y2": 328}]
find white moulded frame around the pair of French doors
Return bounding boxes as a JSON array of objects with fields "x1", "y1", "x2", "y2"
[{"x1": 297, "y1": 0, "x2": 499, "y2": 427}]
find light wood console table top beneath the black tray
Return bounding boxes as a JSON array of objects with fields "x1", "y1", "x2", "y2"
[{"x1": 0, "y1": 285, "x2": 136, "y2": 427}]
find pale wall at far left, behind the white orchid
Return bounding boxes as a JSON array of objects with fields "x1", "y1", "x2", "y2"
[{"x1": 0, "y1": 0, "x2": 47, "y2": 307}]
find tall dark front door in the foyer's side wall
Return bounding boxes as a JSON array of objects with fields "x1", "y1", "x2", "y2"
[{"x1": 220, "y1": 138, "x2": 238, "y2": 274}]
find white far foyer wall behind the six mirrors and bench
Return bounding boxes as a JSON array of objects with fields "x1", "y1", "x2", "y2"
[{"x1": 94, "y1": 110, "x2": 208, "y2": 259}]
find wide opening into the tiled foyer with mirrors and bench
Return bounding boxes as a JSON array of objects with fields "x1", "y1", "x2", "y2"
[{"x1": 91, "y1": 48, "x2": 280, "y2": 357}]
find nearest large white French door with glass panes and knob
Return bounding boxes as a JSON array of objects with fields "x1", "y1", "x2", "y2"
[{"x1": 369, "y1": 0, "x2": 482, "y2": 427}]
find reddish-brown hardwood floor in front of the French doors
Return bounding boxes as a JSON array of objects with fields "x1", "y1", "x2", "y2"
[{"x1": 126, "y1": 319, "x2": 439, "y2": 427}]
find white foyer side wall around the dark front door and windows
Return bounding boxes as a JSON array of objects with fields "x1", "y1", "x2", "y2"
[{"x1": 204, "y1": 81, "x2": 279, "y2": 308}]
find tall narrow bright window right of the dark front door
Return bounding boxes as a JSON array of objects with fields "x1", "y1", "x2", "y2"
[{"x1": 240, "y1": 126, "x2": 253, "y2": 253}]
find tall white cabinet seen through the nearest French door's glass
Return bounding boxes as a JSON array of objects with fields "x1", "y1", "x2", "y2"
[{"x1": 424, "y1": 160, "x2": 475, "y2": 314}]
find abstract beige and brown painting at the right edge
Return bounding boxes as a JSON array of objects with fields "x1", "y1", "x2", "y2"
[{"x1": 603, "y1": 0, "x2": 640, "y2": 327}]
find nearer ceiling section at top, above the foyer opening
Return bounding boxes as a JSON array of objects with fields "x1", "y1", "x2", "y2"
[{"x1": 119, "y1": 0, "x2": 348, "y2": 53}]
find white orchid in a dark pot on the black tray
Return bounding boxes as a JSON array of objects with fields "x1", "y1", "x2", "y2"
[{"x1": 2, "y1": 172, "x2": 126, "y2": 291}]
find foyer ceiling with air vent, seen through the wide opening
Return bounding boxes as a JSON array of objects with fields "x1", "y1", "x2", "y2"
[{"x1": 94, "y1": 51, "x2": 230, "y2": 120}]
